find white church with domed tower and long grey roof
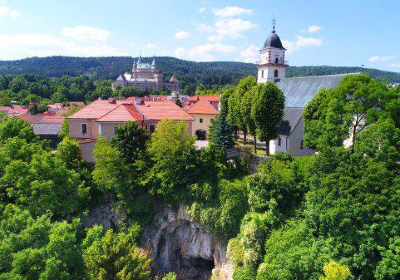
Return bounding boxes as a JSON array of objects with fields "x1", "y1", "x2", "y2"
[{"x1": 257, "y1": 22, "x2": 357, "y2": 156}]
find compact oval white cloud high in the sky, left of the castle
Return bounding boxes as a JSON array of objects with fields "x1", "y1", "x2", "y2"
[{"x1": 61, "y1": 25, "x2": 110, "y2": 41}]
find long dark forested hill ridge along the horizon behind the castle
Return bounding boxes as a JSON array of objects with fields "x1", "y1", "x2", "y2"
[{"x1": 0, "y1": 56, "x2": 400, "y2": 85}]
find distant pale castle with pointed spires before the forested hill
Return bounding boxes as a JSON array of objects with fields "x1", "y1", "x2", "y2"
[{"x1": 111, "y1": 56, "x2": 179, "y2": 92}]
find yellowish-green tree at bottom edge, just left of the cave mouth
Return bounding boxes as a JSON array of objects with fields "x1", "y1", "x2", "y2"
[{"x1": 83, "y1": 226, "x2": 151, "y2": 280}]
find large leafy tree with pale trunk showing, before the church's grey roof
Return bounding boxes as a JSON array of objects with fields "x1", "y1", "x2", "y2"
[{"x1": 303, "y1": 74, "x2": 390, "y2": 151}]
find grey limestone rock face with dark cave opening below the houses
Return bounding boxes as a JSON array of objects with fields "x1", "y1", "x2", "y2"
[{"x1": 141, "y1": 205, "x2": 232, "y2": 280}]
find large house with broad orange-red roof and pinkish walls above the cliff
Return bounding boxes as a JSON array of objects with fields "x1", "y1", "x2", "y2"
[{"x1": 67, "y1": 98, "x2": 194, "y2": 162}]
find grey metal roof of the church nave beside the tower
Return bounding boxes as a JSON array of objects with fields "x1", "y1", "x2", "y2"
[{"x1": 276, "y1": 73, "x2": 358, "y2": 107}]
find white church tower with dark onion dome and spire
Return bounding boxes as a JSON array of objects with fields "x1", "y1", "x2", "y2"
[{"x1": 257, "y1": 19, "x2": 288, "y2": 83}]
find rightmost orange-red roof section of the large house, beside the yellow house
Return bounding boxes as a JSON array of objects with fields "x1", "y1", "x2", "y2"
[{"x1": 136, "y1": 101, "x2": 193, "y2": 121}]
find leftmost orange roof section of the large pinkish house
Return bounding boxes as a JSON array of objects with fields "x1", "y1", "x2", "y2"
[{"x1": 68, "y1": 100, "x2": 126, "y2": 119}]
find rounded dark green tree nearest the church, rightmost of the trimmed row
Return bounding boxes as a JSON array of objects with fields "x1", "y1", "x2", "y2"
[{"x1": 251, "y1": 82, "x2": 285, "y2": 156}]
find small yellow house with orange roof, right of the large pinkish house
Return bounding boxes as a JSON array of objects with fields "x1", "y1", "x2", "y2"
[{"x1": 184, "y1": 99, "x2": 219, "y2": 140}]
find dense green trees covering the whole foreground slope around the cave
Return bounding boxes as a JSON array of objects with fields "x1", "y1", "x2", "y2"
[{"x1": 0, "y1": 75, "x2": 400, "y2": 280}]
